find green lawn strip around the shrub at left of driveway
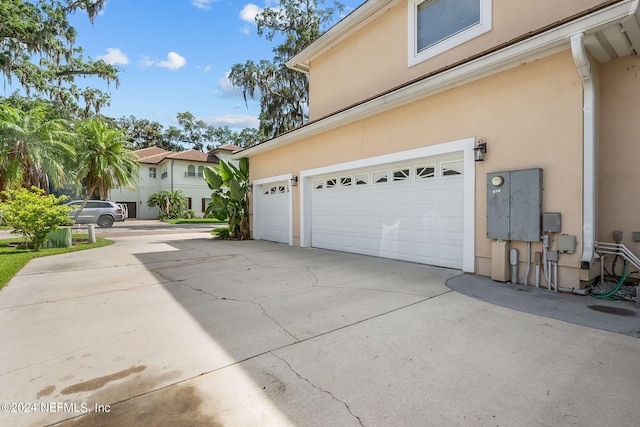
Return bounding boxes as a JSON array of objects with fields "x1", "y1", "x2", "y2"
[{"x1": 0, "y1": 234, "x2": 114, "y2": 289}]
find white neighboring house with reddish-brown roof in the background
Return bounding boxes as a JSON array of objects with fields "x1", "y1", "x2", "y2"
[{"x1": 110, "y1": 144, "x2": 241, "y2": 219}]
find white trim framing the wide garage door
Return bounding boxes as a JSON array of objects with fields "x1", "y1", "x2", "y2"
[{"x1": 300, "y1": 138, "x2": 476, "y2": 273}]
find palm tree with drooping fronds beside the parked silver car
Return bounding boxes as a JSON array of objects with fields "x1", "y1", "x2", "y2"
[{"x1": 76, "y1": 119, "x2": 139, "y2": 213}]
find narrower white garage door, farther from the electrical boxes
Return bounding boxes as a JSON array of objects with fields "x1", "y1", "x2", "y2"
[{"x1": 256, "y1": 181, "x2": 291, "y2": 243}]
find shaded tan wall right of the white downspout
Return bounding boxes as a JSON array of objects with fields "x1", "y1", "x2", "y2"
[{"x1": 597, "y1": 56, "x2": 640, "y2": 255}]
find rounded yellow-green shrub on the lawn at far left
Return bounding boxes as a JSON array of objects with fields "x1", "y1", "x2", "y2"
[{"x1": 1, "y1": 187, "x2": 71, "y2": 250}]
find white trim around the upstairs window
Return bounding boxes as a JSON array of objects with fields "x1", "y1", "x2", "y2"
[{"x1": 407, "y1": 0, "x2": 492, "y2": 67}]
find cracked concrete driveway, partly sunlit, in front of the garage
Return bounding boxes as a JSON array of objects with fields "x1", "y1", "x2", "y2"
[{"x1": 0, "y1": 233, "x2": 640, "y2": 426}]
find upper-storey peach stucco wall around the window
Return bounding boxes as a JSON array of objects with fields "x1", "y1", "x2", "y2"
[{"x1": 309, "y1": 0, "x2": 606, "y2": 120}]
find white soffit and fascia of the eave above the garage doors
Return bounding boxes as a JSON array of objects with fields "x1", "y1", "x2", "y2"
[{"x1": 238, "y1": 0, "x2": 640, "y2": 159}]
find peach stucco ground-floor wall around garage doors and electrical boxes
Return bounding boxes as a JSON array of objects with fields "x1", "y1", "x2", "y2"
[{"x1": 251, "y1": 51, "x2": 582, "y2": 287}]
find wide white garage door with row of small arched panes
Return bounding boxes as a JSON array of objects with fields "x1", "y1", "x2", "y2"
[{"x1": 311, "y1": 154, "x2": 464, "y2": 268}]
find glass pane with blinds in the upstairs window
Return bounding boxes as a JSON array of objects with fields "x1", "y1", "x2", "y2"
[{"x1": 417, "y1": 0, "x2": 481, "y2": 52}]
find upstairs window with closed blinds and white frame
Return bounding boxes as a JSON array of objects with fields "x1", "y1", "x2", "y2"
[{"x1": 409, "y1": 0, "x2": 491, "y2": 66}]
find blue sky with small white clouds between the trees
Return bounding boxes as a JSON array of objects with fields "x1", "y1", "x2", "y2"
[{"x1": 61, "y1": 0, "x2": 364, "y2": 129}]
